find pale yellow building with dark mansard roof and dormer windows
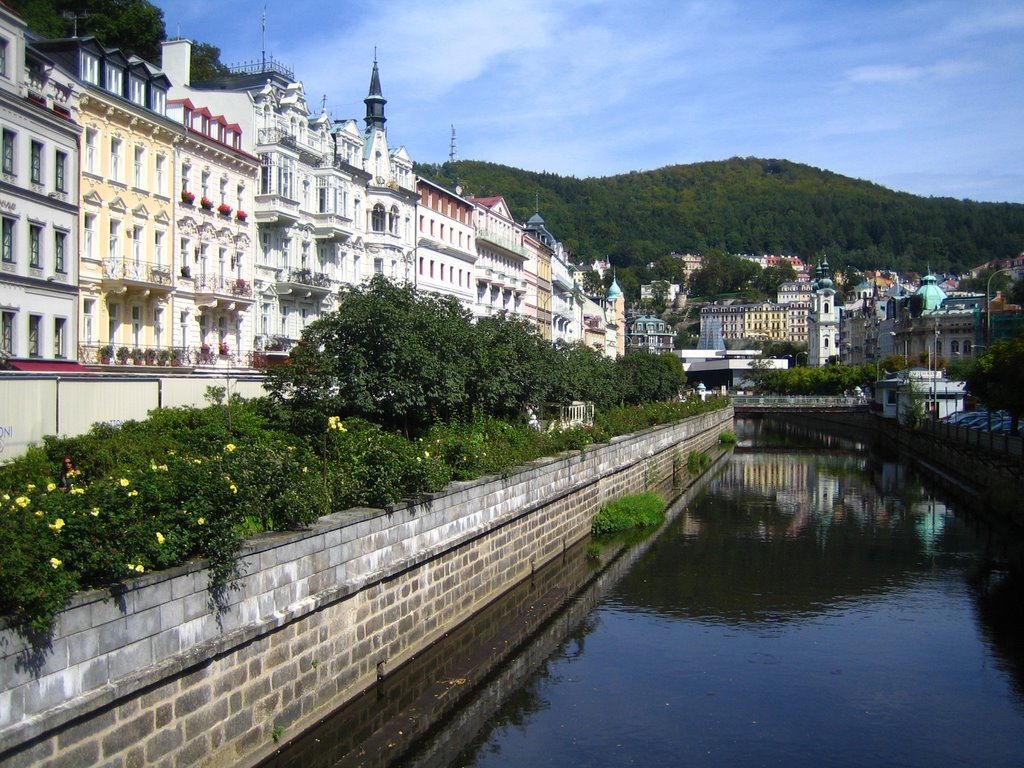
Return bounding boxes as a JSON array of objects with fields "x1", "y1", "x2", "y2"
[{"x1": 38, "y1": 37, "x2": 184, "y2": 365}]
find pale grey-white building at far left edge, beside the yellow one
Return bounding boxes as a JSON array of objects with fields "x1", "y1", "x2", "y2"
[{"x1": 0, "y1": 6, "x2": 81, "y2": 370}]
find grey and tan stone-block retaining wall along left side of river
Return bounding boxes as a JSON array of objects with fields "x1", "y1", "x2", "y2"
[{"x1": 0, "y1": 409, "x2": 732, "y2": 768}]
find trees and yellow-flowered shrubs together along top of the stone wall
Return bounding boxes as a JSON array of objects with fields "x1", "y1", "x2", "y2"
[{"x1": 0, "y1": 282, "x2": 729, "y2": 633}]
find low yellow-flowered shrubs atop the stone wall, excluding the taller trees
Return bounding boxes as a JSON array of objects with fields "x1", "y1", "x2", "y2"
[{"x1": 0, "y1": 397, "x2": 728, "y2": 636}]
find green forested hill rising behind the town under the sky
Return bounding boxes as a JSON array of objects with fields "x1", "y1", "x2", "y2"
[{"x1": 417, "y1": 158, "x2": 1024, "y2": 272}]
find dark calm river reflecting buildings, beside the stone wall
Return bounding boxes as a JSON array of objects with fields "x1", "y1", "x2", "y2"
[{"x1": 258, "y1": 425, "x2": 1024, "y2": 768}]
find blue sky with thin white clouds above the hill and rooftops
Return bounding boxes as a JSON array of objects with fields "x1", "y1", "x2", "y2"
[{"x1": 155, "y1": 0, "x2": 1024, "y2": 203}]
